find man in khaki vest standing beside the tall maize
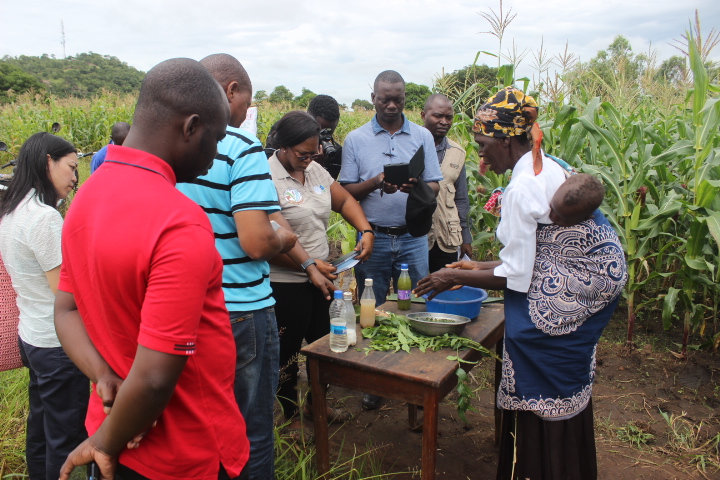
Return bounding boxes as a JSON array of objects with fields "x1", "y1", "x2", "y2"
[{"x1": 421, "y1": 93, "x2": 472, "y2": 273}]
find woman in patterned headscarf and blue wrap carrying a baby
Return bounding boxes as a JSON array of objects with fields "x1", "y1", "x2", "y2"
[{"x1": 415, "y1": 87, "x2": 627, "y2": 480}]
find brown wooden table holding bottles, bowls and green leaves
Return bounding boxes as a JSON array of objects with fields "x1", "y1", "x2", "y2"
[{"x1": 301, "y1": 302, "x2": 505, "y2": 480}]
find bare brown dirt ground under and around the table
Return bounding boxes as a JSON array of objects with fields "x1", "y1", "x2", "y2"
[{"x1": 288, "y1": 314, "x2": 720, "y2": 480}]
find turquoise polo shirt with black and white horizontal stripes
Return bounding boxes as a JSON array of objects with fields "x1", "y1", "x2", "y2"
[{"x1": 177, "y1": 127, "x2": 280, "y2": 313}]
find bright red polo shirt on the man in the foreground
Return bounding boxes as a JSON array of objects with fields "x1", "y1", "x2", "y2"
[{"x1": 58, "y1": 146, "x2": 249, "y2": 480}]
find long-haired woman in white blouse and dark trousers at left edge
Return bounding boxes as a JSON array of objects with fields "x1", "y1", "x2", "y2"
[{"x1": 0, "y1": 133, "x2": 90, "y2": 480}]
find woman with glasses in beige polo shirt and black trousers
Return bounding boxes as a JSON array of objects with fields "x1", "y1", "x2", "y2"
[{"x1": 268, "y1": 111, "x2": 375, "y2": 430}]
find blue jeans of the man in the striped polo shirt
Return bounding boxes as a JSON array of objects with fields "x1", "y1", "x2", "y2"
[{"x1": 230, "y1": 307, "x2": 280, "y2": 480}]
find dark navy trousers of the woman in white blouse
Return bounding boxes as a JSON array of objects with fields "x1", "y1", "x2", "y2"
[{"x1": 19, "y1": 340, "x2": 90, "y2": 480}]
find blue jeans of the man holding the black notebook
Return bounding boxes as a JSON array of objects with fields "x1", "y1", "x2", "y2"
[{"x1": 355, "y1": 232, "x2": 428, "y2": 306}]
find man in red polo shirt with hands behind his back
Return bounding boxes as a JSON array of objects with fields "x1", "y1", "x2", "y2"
[{"x1": 55, "y1": 59, "x2": 249, "y2": 480}]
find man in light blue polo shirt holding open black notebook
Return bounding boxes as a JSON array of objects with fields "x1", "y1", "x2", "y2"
[{"x1": 339, "y1": 70, "x2": 442, "y2": 409}]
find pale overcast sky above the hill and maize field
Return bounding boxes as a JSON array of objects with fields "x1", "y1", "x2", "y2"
[{"x1": 0, "y1": 0, "x2": 720, "y2": 105}]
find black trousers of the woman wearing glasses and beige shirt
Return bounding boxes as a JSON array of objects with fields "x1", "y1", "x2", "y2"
[{"x1": 270, "y1": 282, "x2": 330, "y2": 418}]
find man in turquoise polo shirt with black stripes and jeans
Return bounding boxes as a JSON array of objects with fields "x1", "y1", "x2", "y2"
[{"x1": 178, "y1": 54, "x2": 297, "y2": 480}]
